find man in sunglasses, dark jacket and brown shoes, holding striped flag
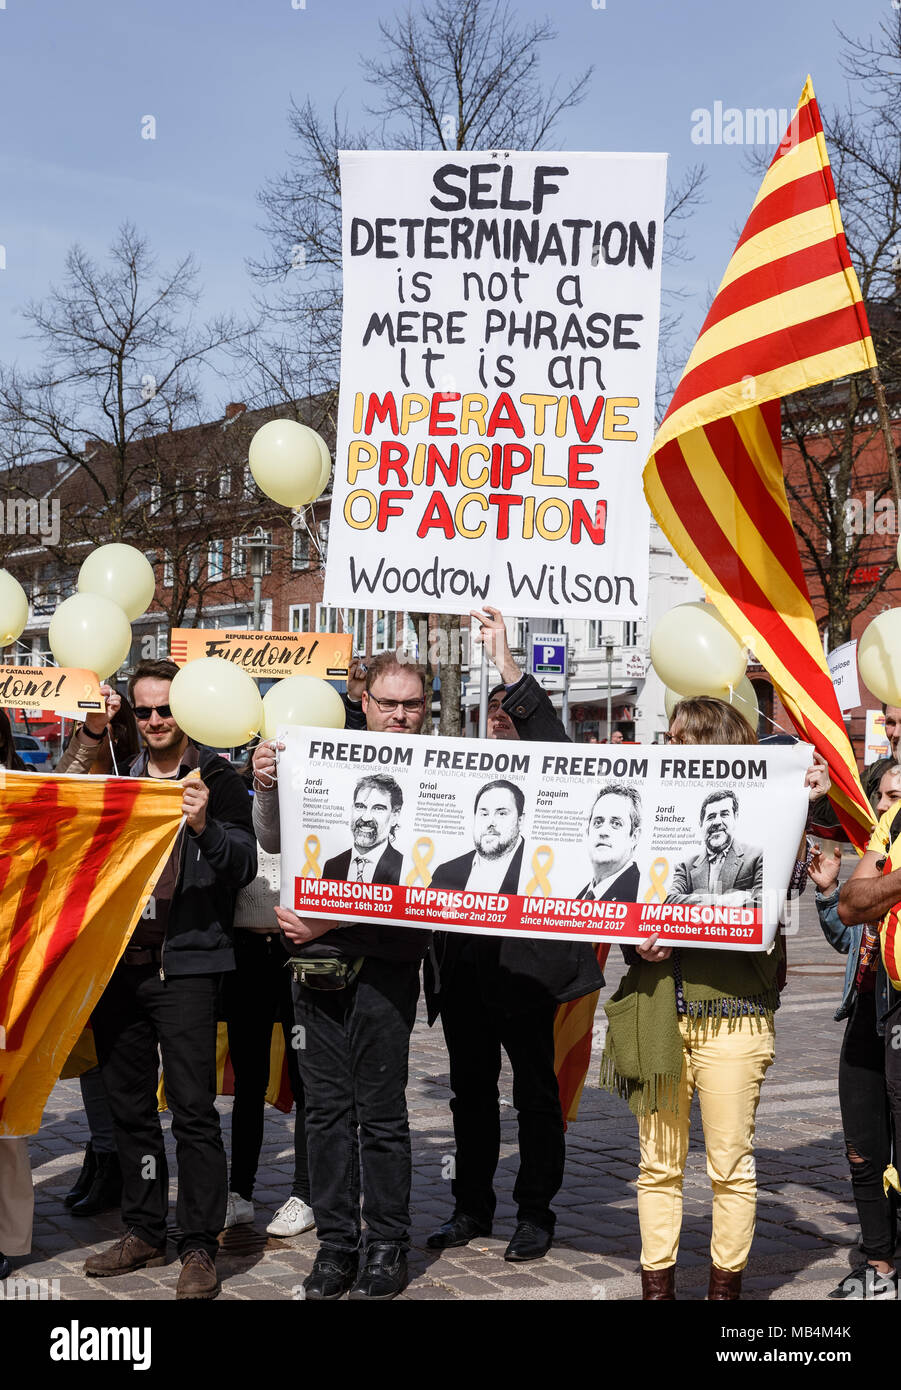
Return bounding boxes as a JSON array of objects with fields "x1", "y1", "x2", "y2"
[{"x1": 79, "y1": 662, "x2": 257, "y2": 1298}]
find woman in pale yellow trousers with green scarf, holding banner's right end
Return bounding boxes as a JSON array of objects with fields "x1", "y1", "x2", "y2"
[{"x1": 601, "y1": 696, "x2": 829, "y2": 1301}]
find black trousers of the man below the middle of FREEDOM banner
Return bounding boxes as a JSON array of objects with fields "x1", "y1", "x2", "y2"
[{"x1": 441, "y1": 960, "x2": 566, "y2": 1232}]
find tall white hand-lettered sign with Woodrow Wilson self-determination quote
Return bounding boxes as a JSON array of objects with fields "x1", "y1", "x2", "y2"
[{"x1": 324, "y1": 150, "x2": 666, "y2": 619}]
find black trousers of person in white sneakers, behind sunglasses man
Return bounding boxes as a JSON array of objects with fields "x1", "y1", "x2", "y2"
[{"x1": 222, "y1": 930, "x2": 310, "y2": 1202}]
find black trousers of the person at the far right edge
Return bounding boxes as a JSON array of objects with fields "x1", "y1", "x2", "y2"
[{"x1": 838, "y1": 992, "x2": 895, "y2": 1262}]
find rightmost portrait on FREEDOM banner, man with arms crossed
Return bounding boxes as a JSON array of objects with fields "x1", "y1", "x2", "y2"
[{"x1": 666, "y1": 791, "x2": 763, "y2": 908}]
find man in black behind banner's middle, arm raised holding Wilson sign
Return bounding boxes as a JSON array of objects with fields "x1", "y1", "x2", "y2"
[{"x1": 424, "y1": 609, "x2": 603, "y2": 1261}]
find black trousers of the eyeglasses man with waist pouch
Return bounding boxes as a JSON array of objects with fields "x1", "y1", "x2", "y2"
[{"x1": 293, "y1": 956, "x2": 419, "y2": 1254}]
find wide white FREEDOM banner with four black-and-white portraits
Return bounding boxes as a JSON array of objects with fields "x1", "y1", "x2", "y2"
[{"x1": 278, "y1": 727, "x2": 812, "y2": 951}]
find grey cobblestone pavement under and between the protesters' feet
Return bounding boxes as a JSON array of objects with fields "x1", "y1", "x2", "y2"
[{"x1": 14, "y1": 891, "x2": 878, "y2": 1307}]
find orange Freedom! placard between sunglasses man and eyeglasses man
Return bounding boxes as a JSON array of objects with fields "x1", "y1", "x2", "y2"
[{"x1": 170, "y1": 627, "x2": 353, "y2": 680}]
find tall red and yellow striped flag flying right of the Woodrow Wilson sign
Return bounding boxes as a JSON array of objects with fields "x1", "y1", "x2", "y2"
[{"x1": 644, "y1": 78, "x2": 876, "y2": 847}]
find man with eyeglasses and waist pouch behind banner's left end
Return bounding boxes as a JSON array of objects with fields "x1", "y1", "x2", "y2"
[{"x1": 253, "y1": 652, "x2": 428, "y2": 1300}]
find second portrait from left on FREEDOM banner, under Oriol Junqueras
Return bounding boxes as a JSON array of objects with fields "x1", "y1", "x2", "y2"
[{"x1": 431, "y1": 777, "x2": 526, "y2": 892}]
